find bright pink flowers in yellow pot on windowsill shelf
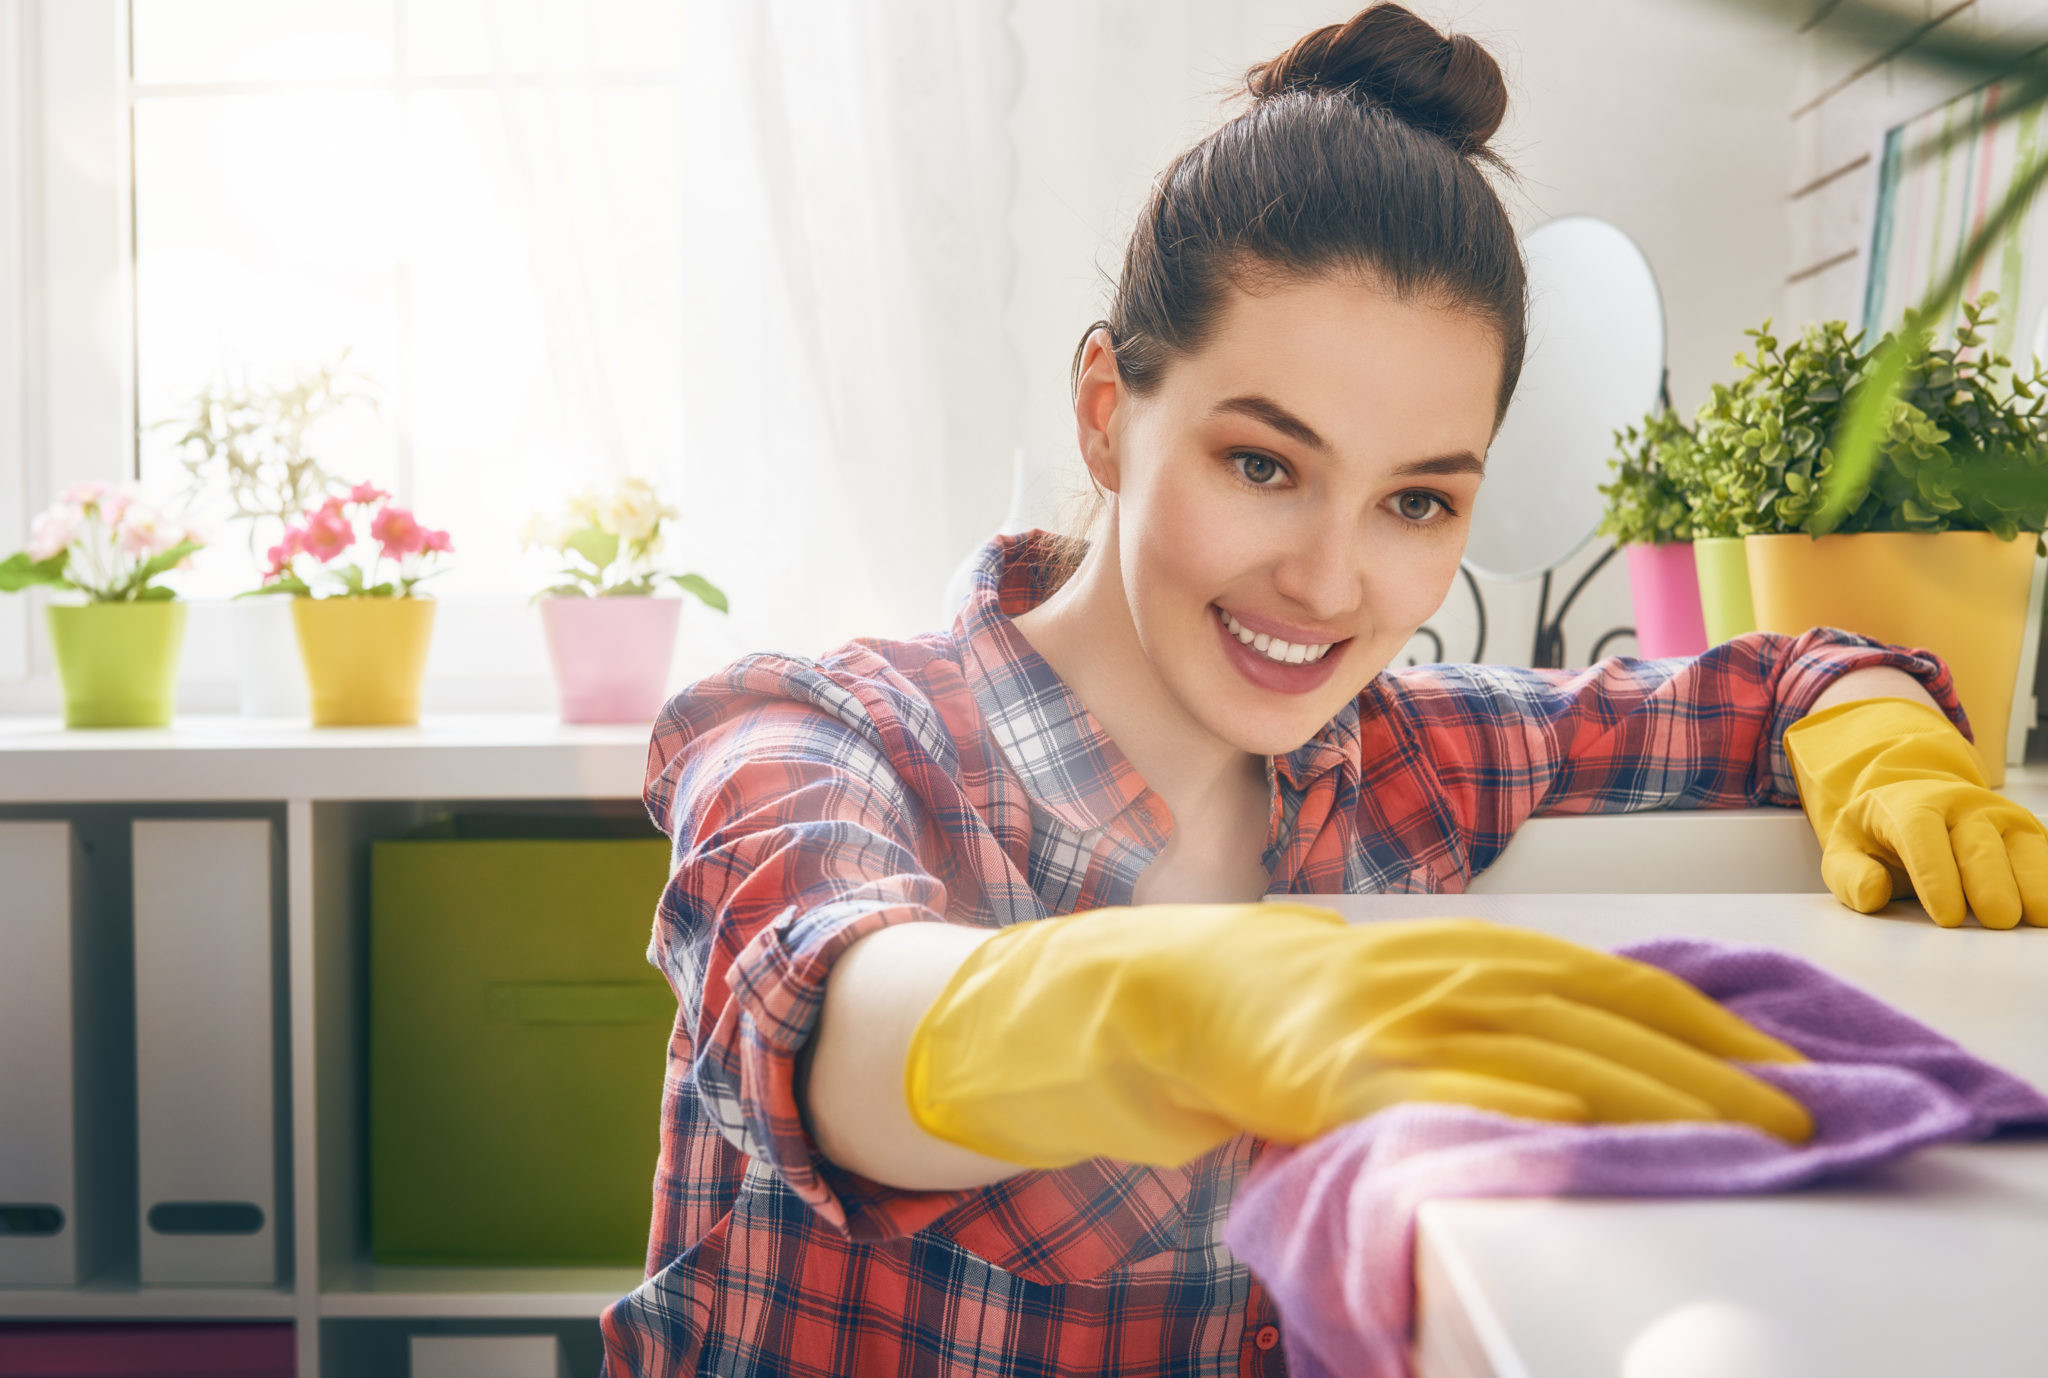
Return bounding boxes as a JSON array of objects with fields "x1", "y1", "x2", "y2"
[{"x1": 244, "y1": 483, "x2": 453, "y2": 727}]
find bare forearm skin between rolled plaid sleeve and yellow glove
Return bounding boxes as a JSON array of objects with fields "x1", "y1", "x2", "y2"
[{"x1": 799, "y1": 923, "x2": 1024, "y2": 1192}]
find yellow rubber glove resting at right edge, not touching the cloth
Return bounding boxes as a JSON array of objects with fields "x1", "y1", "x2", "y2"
[{"x1": 1786, "y1": 698, "x2": 2048, "y2": 928}]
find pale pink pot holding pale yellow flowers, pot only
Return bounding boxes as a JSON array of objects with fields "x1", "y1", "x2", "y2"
[{"x1": 541, "y1": 598, "x2": 682, "y2": 723}]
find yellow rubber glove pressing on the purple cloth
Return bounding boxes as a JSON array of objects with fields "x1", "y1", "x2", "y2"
[{"x1": 905, "y1": 905, "x2": 1812, "y2": 1167}]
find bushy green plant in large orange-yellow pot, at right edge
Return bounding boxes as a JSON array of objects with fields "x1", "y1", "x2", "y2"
[{"x1": 1700, "y1": 293, "x2": 2048, "y2": 784}]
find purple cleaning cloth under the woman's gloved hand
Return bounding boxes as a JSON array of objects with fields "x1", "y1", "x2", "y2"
[{"x1": 1225, "y1": 938, "x2": 2048, "y2": 1378}]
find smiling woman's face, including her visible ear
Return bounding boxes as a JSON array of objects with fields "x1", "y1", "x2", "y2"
[{"x1": 1077, "y1": 276, "x2": 1501, "y2": 756}]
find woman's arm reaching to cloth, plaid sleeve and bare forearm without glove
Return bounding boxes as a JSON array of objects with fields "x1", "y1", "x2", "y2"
[{"x1": 647, "y1": 683, "x2": 1018, "y2": 1241}]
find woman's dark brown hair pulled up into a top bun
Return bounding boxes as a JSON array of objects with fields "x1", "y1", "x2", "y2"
[{"x1": 1073, "y1": 4, "x2": 1526, "y2": 424}]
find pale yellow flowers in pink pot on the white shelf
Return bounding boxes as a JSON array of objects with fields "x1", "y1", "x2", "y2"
[{"x1": 524, "y1": 479, "x2": 727, "y2": 723}]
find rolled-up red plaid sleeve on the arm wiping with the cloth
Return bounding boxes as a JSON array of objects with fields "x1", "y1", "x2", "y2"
[{"x1": 645, "y1": 700, "x2": 983, "y2": 1239}]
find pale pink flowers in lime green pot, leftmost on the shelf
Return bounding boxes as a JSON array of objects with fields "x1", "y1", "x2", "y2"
[{"x1": 0, "y1": 483, "x2": 203, "y2": 727}]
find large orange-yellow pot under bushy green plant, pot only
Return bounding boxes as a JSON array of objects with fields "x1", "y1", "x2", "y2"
[{"x1": 1747, "y1": 530, "x2": 2034, "y2": 786}]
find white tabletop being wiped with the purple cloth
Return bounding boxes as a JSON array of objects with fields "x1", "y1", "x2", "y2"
[{"x1": 1310, "y1": 895, "x2": 2048, "y2": 1378}]
